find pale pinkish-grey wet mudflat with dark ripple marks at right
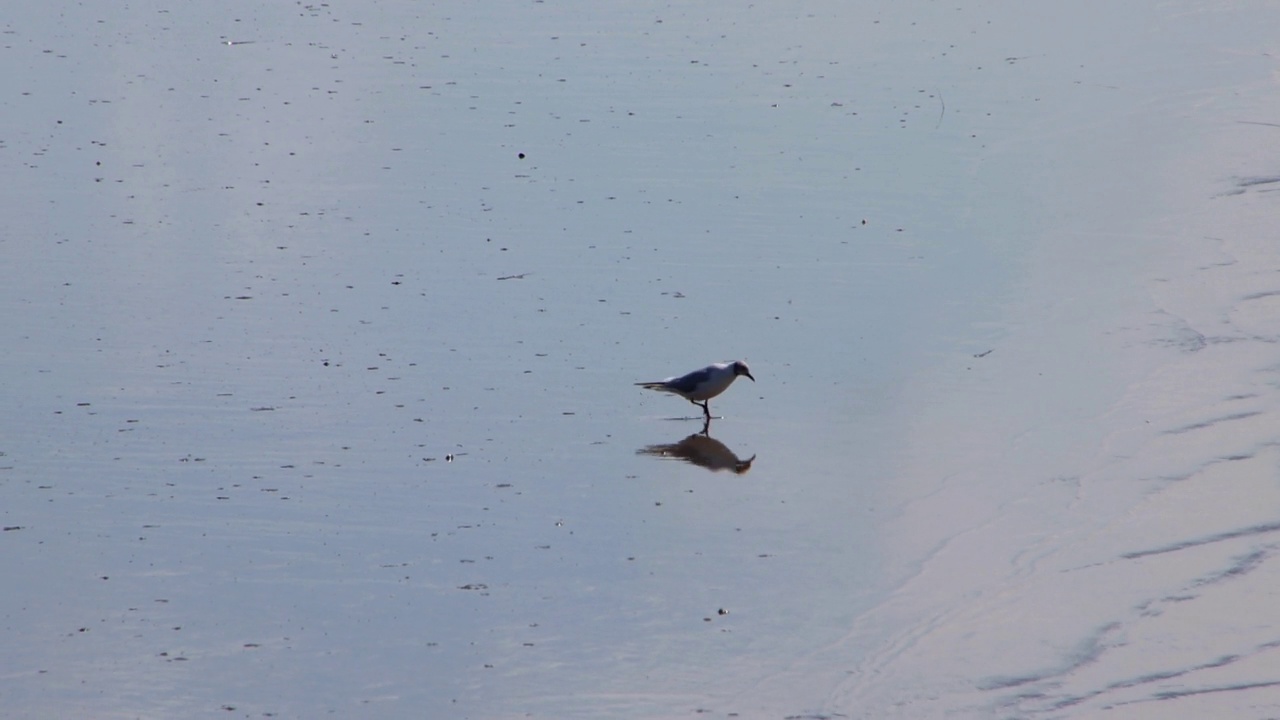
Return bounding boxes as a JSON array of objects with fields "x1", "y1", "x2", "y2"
[{"x1": 828, "y1": 26, "x2": 1280, "y2": 717}]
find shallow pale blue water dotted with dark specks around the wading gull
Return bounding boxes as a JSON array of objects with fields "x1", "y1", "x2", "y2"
[{"x1": 0, "y1": 3, "x2": 1280, "y2": 717}]
